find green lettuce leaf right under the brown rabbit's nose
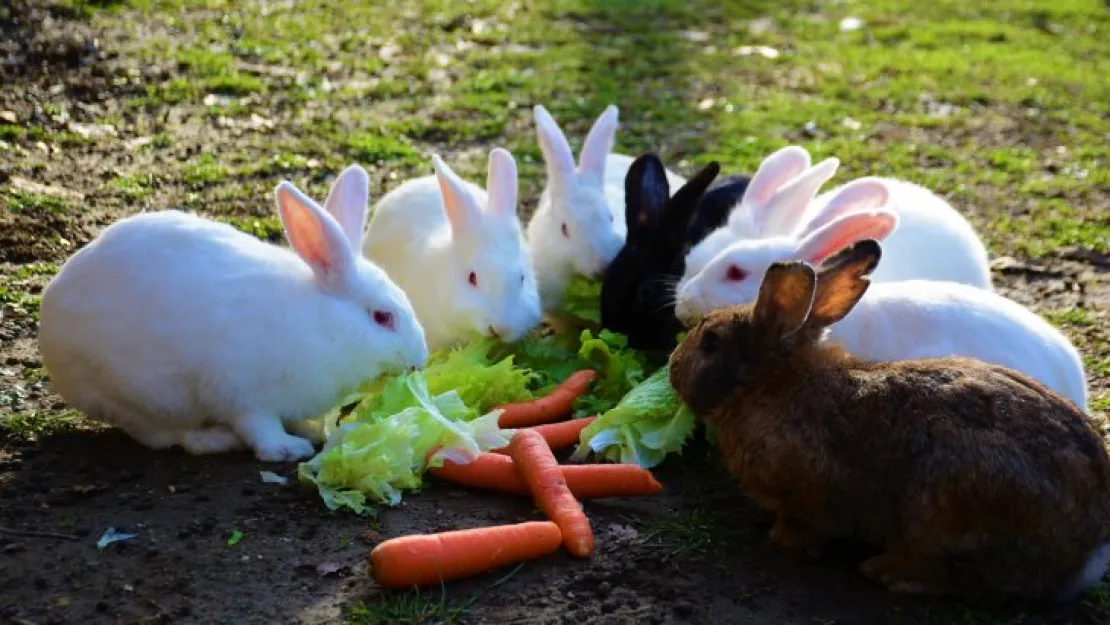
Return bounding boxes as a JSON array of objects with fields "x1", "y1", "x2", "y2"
[{"x1": 572, "y1": 366, "x2": 695, "y2": 468}]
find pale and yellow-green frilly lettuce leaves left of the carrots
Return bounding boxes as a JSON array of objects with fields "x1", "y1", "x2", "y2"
[{"x1": 297, "y1": 341, "x2": 533, "y2": 514}]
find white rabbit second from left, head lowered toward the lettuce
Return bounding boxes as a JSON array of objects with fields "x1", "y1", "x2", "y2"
[{"x1": 364, "y1": 148, "x2": 542, "y2": 351}]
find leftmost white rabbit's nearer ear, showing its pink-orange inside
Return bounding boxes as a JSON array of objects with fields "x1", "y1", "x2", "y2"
[{"x1": 274, "y1": 181, "x2": 355, "y2": 291}]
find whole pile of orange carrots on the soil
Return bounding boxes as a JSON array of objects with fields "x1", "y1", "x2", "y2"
[{"x1": 370, "y1": 370, "x2": 663, "y2": 588}]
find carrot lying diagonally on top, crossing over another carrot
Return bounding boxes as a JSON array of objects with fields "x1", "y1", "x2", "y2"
[{"x1": 508, "y1": 430, "x2": 594, "y2": 557}]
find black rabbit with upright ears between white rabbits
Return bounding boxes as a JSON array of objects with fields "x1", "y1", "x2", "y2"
[{"x1": 602, "y1": 153, "x2": 750, "y2": 351}]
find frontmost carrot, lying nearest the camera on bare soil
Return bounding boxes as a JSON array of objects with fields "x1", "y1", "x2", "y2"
[{"x1": 370, "y1": 521, "x2": 563, "y2": 588}]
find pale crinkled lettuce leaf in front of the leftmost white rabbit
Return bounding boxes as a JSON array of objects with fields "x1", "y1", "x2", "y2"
[{"x1": 297, "y1": 372, "x2": 512, "y2": 514}]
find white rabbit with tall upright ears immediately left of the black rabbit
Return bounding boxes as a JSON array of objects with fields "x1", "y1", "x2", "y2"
[{"x1": 527, "y1": 104, "x2": 686, "y2": 312}]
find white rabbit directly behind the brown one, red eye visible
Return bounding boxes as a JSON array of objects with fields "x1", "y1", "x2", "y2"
[{"x1": 676, "y1": 209, "x2": 1087, "y2": 411}]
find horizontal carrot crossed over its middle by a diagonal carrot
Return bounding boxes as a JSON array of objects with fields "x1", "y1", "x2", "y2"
[{"x1": 430, "y1": 453, "x2": 663, "y2": 500}]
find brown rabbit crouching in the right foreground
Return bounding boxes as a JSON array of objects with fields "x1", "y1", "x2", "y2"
[{"x1": 670, "y1": 240, "x2": 1110, "y2": 601}]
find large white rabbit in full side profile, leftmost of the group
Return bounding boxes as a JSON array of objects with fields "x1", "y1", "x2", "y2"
[{"x1": 39, "y1": 165, "x2": 427, "y2": 462}]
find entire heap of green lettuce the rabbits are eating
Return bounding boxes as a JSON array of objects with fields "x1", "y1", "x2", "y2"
[{"x1": 297, "y1": 297, "x2": 694, "y2": 514}]
